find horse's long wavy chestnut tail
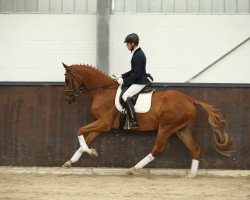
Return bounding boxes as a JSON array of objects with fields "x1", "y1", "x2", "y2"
[{"x1": 194, "y1": 100, "x2": 235, "y2": 156}]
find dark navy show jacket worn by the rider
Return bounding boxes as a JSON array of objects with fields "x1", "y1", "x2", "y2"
[{"x1": 122, "y1": 48, "x2": 150, "y2": 86}]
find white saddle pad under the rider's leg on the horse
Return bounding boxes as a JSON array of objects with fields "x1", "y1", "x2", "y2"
[{"x1": 115, "y1": 85, "x2": 154, "y2": 113}]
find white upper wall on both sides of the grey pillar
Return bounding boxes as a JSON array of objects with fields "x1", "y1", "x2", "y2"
[{"x1": 0, "y1": 14, "x2": 250, "y2": 83}]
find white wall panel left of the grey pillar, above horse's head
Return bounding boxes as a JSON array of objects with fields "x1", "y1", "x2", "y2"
[{"x1": 0, "y1": 14, "x2": 96, "y2": 81}]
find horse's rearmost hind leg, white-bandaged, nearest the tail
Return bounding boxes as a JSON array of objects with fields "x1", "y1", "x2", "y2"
[{"x1": 176, "y1": 124, "x2": 201, "y2": 178}]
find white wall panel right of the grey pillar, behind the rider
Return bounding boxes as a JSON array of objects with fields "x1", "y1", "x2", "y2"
[{"x1": 110, "y1": 14, "x2": 250, "y2": 83}]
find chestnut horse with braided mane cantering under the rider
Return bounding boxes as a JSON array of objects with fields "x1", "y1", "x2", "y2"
[{"x1": 63, "y1": 64, "x2": 235, "y2": 178}]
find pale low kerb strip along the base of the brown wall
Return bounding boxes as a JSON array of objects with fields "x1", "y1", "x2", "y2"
[{"x1": 0, "y1": 166, "x2": 250, "y2": 177}]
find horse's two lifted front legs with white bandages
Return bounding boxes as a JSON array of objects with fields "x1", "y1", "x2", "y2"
[{"x1": 62, "y1": 120, "x2": 110, "y2": 168}]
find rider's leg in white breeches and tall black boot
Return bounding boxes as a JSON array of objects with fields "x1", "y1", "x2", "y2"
[{"x1": 122, "y1": 84, "x2": 145, "y2": 128}]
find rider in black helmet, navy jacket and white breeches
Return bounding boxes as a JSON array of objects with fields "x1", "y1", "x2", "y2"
[{"x1": 117, "y1": 33, "x2": 152, "y2": 128}]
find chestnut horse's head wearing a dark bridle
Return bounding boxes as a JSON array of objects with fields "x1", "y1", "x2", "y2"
[{"x1": 62, "y1": 63, "x2": 84, "y2": 103}]
